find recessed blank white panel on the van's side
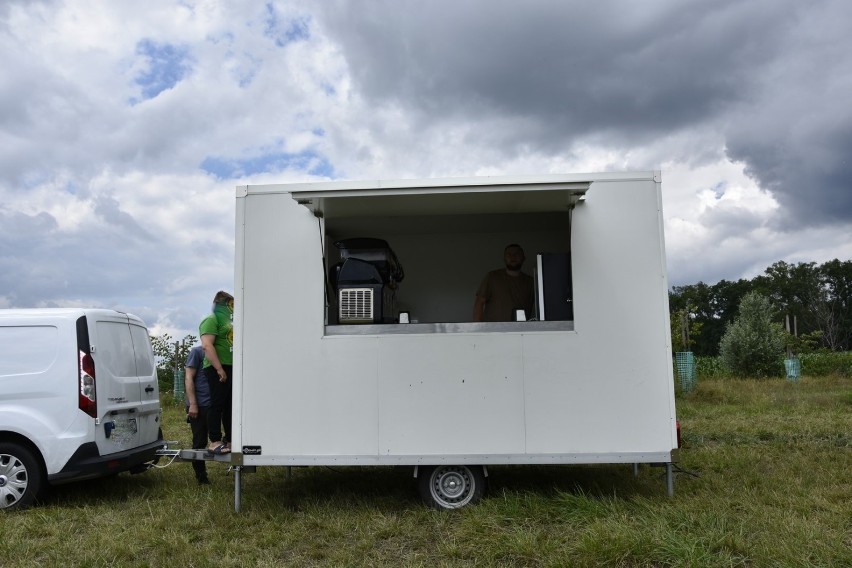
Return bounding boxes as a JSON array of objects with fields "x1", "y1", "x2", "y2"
[{"x1": 0, "y1": 325, "x2": 58, "y2": 376}]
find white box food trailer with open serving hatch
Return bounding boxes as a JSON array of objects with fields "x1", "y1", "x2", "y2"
[{"x1": 230, "y1": 172, "x2": 677, "y2": 510}]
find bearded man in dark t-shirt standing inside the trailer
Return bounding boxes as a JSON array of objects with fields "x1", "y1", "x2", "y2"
[{"x1": 473, "y1": 243, "x2": 535, "y2": 322}]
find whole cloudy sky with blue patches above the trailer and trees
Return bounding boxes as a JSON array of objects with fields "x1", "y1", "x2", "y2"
[{"x1": 0, "y1": 0, "x2": 852, "y2": 337}]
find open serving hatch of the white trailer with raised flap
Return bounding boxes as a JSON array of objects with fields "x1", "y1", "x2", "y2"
[{"x1": 292, "y1": 182, "x2": 589, "y2": 335}]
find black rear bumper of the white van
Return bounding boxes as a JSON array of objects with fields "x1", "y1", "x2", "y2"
[{"x1": 47, "y1": 439, "x2": 166, "y2": 484}]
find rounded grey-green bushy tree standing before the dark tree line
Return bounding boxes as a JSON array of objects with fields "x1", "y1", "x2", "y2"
[{"x1": 719, "y1": 292, "x2": 786, "y2": 377}]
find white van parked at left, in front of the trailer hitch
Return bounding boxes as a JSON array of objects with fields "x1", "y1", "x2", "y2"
[{"x1": 0, "y1": 309, "x2": 164, "y2": 509}]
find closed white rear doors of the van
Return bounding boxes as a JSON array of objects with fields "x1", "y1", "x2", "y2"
[{"x1": 87, "y1": 310, "x2": 160, "y2": 455}]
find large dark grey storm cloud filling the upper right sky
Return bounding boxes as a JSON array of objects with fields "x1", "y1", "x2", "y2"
[{"x1": 321, "y1": 0, "x2": 852, "y2": 224}]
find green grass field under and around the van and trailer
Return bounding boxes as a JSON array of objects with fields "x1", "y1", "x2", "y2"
[{"x1": 0, "y1": 377, "x2": 852, "y2": 568}]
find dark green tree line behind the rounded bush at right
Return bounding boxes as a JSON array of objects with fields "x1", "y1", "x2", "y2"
[{"x1": 669, "y1": 259, "x2": 852, "y2": 356}]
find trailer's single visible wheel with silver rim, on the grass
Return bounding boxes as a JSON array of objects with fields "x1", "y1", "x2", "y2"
[{"x1": 417, "y1": 465, "x2": 485, "y2": 510}]
